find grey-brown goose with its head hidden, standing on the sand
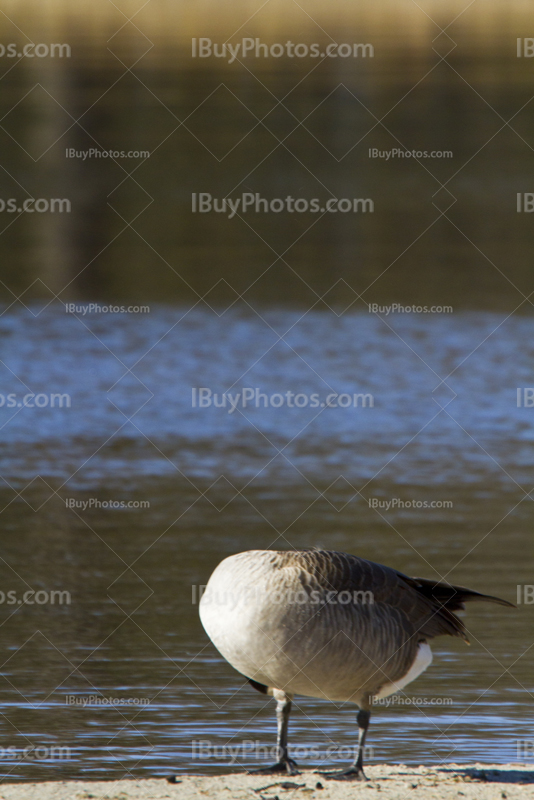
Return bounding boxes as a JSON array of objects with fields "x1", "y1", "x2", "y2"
[{"x1": 199, "y1": 549, "x2": 515, "y2": 780}]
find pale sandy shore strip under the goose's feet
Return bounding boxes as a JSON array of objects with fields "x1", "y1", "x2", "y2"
[{"x1": 0, "y1": 764, "x2": 534, "y2": 800}]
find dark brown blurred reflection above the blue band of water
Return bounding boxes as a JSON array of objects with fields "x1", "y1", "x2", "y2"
[{"x1": 0, "y1": 25, "x2": 534, "y2": 311}]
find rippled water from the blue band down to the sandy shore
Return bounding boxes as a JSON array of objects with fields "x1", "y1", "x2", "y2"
[{"x1": 0, "y1": 304, "x2": 534, "y2": 780}]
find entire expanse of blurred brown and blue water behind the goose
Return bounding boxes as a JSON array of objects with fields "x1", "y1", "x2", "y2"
[{"x1": 0, "y1": 0, "x2": 534, "y2": 782}]
